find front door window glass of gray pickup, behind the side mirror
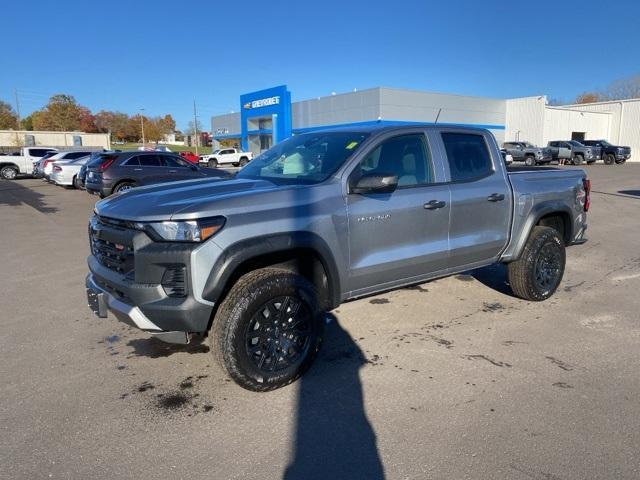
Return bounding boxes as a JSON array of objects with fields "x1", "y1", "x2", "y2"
[{"x1": 355, "y1": 134, "x2": 433, "y2": 187}]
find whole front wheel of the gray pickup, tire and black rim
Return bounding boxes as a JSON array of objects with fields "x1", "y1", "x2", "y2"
[{"x1": 211, "y1": 268, "x2": 323, "y2": 391}]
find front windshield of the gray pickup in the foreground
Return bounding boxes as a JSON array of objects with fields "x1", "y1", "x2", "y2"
[{"x1": 237, "y1": 132, "x2": 369, "y2": 185}]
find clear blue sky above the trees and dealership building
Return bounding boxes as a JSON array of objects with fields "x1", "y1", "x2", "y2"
[{"x1": 0, "y1": 0, "x2": 640, "y2": 129}]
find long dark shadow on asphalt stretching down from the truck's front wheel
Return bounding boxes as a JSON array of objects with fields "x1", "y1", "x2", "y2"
[{"x1": 283, "y1": 314, "x2": 384, "y2": 480}]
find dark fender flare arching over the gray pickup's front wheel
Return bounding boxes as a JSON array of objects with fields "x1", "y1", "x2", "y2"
[{"x1": 202, "y1": 232, "x2": 342, "y2": 308}]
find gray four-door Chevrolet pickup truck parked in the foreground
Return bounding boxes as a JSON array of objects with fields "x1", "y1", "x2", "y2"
[{"x1": 86, "y1": 125, "x2": 590, "y2": 391}]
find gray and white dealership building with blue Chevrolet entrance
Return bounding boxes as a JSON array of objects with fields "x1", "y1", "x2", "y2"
[{"x1": 211, "y1": 85, "x2": 640, "y2": 161}]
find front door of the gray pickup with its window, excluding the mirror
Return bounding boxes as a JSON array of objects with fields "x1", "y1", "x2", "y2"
[{"x1": 347, "y1": 132, "x2": 449, "y2": 295}]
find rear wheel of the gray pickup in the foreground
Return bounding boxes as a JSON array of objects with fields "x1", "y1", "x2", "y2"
[{"x1": 507, "y1": 226, "x2": 566, "y2": 302}]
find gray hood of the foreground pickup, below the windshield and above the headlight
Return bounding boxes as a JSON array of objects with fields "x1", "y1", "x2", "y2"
[{"x1": 96, "y1": 178, "x2": 283, "y2": 222}]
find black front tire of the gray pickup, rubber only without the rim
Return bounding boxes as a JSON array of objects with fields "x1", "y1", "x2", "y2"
[{"x1": 210, "y1": 268, "x2": 324, "y2": 392}]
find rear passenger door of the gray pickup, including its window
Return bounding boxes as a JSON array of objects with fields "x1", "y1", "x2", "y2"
[{"x1": 439, "y1": 129, "x2": 512, "y2": 270}]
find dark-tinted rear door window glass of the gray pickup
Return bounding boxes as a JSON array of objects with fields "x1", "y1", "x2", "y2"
[{"x1": 442, "y1": 132, "x2": 493, "y2": 182}]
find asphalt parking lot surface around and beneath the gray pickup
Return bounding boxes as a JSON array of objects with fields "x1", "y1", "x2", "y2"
[{"x1": 0, "y1": 164, "x2": 640, "y2": 480}]
